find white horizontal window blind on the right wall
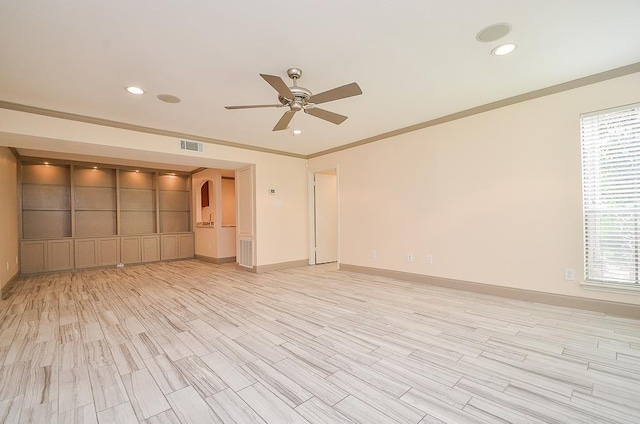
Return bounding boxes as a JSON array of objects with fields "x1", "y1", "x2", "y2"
[{"x1": 580, "y1": 103, "x2": 640, "y2": 286}]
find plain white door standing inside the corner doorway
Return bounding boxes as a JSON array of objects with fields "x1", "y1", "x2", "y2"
[{"x1": 314, "y1": 174, "x2": 338, "y2": 264}]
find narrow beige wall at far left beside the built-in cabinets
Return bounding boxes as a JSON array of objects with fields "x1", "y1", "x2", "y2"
[{"x1": 0, "y1": 147, "x2": 18, "y2": 291}]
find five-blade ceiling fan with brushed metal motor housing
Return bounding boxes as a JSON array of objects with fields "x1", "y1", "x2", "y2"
[{"x1": 225, "y1": 68, "x2": 362, "y2": 131}]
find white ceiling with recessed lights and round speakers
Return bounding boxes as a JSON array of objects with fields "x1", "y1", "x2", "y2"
[{"x1": 0, "y1": 0, "x2": 640, "y2": 155}]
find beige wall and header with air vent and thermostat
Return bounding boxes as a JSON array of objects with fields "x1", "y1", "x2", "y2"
[{"x1": 0, "y1": 109, "x2": 308, "y2": 266}]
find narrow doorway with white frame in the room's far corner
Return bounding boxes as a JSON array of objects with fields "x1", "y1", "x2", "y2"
[{"x1": 309, "y1": 167, "x2": 339, "y2": 265}]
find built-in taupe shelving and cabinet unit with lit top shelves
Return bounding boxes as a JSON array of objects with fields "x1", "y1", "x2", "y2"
[{"x1": 20, "y1": 162, "x2": 194, "y2": 274}]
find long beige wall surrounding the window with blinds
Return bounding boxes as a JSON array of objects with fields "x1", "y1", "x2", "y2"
[{"x1": 309, "y1": 74, "x2": 640, "y2": 304}]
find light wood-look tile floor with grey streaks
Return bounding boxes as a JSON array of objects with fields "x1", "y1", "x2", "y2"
[{"x1": 0, "y1": 260, "x2": 640, "y2": 424}]
